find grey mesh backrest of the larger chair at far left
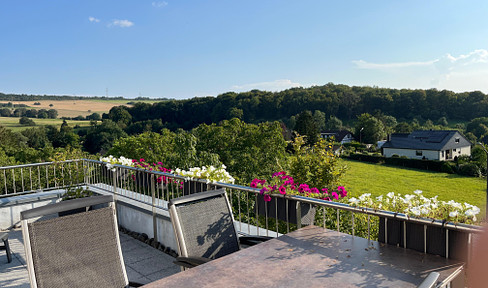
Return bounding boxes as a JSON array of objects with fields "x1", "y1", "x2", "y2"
[{"x1": 21, "y1": 196, "x2": 129, "y2": 287}]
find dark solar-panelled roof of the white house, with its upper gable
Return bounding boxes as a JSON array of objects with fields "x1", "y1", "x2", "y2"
[{"x1": 382, "y1": 130, "x2": 472, "y2": 151}]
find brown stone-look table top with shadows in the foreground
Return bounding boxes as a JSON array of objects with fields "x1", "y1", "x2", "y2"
[{"x1": 144, "y1": 226, "x2": 463, "y2": 288}]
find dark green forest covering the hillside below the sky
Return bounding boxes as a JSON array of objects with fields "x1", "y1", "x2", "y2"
[{"x1": 109, "y1": 83, "x2": 488, "y2": 129}]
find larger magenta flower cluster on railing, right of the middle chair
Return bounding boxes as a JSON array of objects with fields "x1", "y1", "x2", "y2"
[{"x1": 250, "y1": 171, "x2": 347, "y2": 202}]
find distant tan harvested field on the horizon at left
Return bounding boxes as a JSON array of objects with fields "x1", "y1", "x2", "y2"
[{"x1": 0, "y1": 99, "x2": 163, "y2": 118}]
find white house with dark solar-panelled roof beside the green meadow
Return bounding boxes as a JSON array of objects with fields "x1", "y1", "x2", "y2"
[{"x1": 381, "y1": 130, "x2": 472, "y2": 161}]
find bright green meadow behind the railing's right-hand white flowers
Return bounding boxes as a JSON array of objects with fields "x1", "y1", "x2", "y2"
[{"x1": 341, "y1": 160, "x2": 486, "y2": 215}]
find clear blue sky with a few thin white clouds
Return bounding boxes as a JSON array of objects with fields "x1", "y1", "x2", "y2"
[{"x1": 0, "y1": 0, "x2": 488, "y2": 99}]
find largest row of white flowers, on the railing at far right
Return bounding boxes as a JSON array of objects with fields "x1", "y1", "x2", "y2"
[{"x1": 349, "y1": 190, "x2": 480, "y2": 224}]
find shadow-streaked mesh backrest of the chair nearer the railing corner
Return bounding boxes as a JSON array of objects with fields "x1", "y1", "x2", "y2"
[{"x1": 169, "y1": 189, "x2": 239, "y2": 259}]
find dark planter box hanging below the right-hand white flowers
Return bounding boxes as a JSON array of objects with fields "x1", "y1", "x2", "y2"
[{"x1": 378, "y1": 217, "x2": 469, "y2": 261}]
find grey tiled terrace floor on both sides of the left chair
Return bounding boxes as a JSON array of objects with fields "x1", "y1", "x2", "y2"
[{"x1": 0, "y1": 229, "x2": 180, "y2": 287}]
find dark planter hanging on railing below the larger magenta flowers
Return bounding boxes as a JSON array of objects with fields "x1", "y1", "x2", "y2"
[{"x1": 257, "y1": 195, "x2": 317, "y2": 225}]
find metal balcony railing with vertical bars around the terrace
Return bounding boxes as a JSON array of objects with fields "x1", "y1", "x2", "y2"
[{"x1": 0, "y1": 159, "x2": 481, "y2": 260}]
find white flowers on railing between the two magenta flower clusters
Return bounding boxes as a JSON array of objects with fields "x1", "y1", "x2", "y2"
[{"x1": 174, "y1": 165, "x2": 235, "y2": 184}]
